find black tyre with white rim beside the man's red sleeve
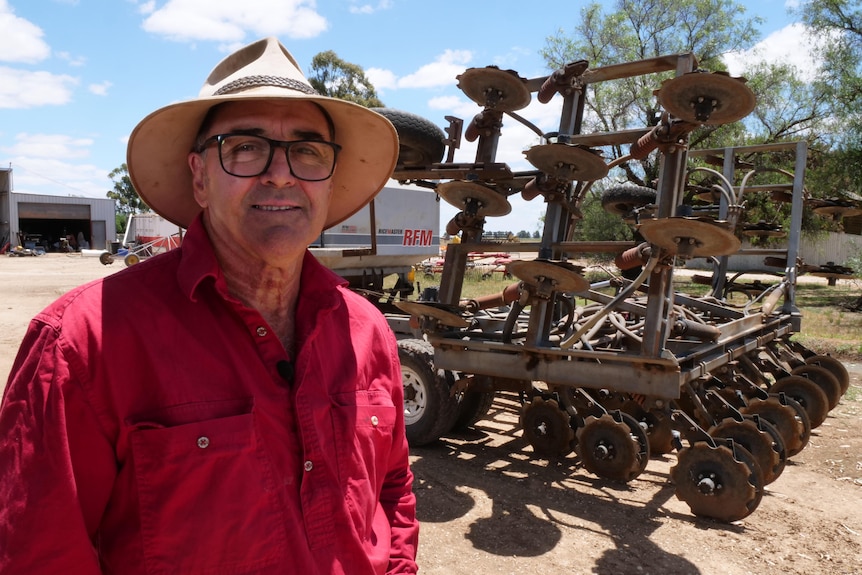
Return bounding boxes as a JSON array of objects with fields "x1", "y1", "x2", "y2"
[{"x1": 398, "y1": 339, "x2": 458, "y2": 447}]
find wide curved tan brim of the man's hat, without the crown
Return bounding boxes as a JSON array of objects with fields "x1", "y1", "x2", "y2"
[{"x1": 126, "y1": 91, "x2": 398, "y2": 228}]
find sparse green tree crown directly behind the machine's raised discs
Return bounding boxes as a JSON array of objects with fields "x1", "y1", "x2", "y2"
[{"x1": 541, "y1": 0, "x2": 760, "y2": 186}]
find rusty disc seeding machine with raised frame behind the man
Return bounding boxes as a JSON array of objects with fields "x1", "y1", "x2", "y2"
[{"x1": 380, "y1": 54, "x2": 849, "y2": 522}]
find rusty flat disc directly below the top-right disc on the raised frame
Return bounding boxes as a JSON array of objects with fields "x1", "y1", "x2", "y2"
[{"x1": 638, "y1": 217, "x2": 741, "y2": 257}]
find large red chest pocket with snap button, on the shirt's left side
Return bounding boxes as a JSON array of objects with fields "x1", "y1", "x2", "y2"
[{"x1": 130, "y1": 413, "x2": 286, "y2": 573}]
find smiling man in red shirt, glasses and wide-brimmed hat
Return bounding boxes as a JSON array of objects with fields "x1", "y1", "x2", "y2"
[{"x1": 0, "y1": 38, "x2": 418, "y2": 575}]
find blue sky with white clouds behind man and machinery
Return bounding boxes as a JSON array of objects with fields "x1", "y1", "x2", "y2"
[{"x1": 0, "y1": 0, "x2": 811, "y2": 232}]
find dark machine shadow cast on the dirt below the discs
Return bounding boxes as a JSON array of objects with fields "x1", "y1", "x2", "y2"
[{"x1": 411, "y1": 394, "x2": 744, "y2": 574}]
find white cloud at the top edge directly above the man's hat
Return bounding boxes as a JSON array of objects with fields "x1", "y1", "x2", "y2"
[{"x1": 140, "y1": 0, "x2": 328, "y2": 43}]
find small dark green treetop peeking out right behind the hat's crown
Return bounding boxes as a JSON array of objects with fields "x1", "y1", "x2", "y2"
[{"x1": 308, "y1": 50, "x2": 383, "y2": 108}]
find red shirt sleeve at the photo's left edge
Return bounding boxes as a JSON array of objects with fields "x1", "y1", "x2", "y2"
[{"x1": 0, "y1": 319, "x2": 116, "y2": 575}]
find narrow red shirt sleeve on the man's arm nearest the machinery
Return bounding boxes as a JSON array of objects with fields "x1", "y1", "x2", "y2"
[{"x1": 380, "y1": 336, "x2": 419, "y2": 575}]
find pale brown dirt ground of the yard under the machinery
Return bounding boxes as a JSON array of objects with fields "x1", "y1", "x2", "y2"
[{"x1": 5, "y1": 254, "x2": 862, "y2": 575}]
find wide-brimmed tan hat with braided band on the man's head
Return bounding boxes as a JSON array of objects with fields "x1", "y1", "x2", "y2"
[{"x1": 127, "y1": 38, "x2": 398, "y2": 228}]
